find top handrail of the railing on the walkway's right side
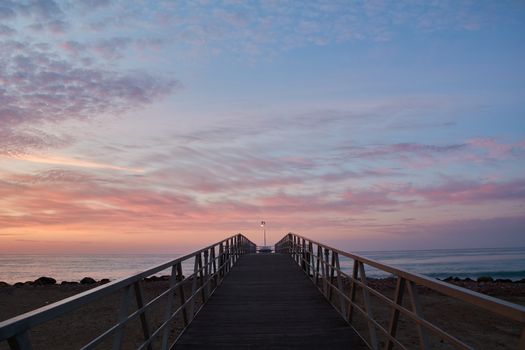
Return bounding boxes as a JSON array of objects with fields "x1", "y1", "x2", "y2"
[{"x1": 276, "y1": 233, "x2": 525, "y2": 323}]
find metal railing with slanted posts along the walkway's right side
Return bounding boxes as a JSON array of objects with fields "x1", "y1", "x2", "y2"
[{"x1": 275, "y1": 233, "x2": 525, "y2": 350}]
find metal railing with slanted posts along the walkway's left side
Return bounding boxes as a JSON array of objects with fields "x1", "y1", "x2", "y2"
[{"x1": 0, "y1": 234, "x2": 255, "y2": 350}]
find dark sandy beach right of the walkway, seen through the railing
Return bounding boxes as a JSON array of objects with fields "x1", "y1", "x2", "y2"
[{"x1": 344, "y1": 279, "x2": 525, "y2": 350}]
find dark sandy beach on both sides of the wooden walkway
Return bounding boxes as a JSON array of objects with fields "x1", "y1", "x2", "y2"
[{"x1": 0, "y1": 279, "x2": 525, "y2": 350}]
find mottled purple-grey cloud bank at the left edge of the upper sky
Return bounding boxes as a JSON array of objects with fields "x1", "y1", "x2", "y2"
[{"x1": 0, "y1": 40, "x2": 178, "y2": 153}]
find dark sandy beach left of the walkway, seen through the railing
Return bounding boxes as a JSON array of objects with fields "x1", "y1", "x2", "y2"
[{"x1": 0, "y1": 280, "x2": 189, "y2": 350}]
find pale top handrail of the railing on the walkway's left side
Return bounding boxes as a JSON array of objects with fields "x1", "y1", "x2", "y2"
[{"x1": 0, "y1": 233, "x2": 255, "y2": 348}]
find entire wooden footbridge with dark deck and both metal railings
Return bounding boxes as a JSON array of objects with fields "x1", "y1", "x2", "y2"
[{"x1": 0, "y1": 233, "x2": 525, "y2": 350}]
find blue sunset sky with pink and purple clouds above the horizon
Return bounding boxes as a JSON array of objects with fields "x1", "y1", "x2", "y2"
[{"x1": 0, "y1": 0, "x2": 525, "y2": 253}]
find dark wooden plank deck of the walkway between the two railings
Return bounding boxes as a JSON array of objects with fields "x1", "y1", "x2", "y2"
[{"x1": 174, "y1": 254, "x2": 366, "y2": 350}]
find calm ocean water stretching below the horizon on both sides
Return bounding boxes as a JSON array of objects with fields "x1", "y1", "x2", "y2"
[{"x1": 0, "y1": 248, "x2": 525, "y2": 283}]
